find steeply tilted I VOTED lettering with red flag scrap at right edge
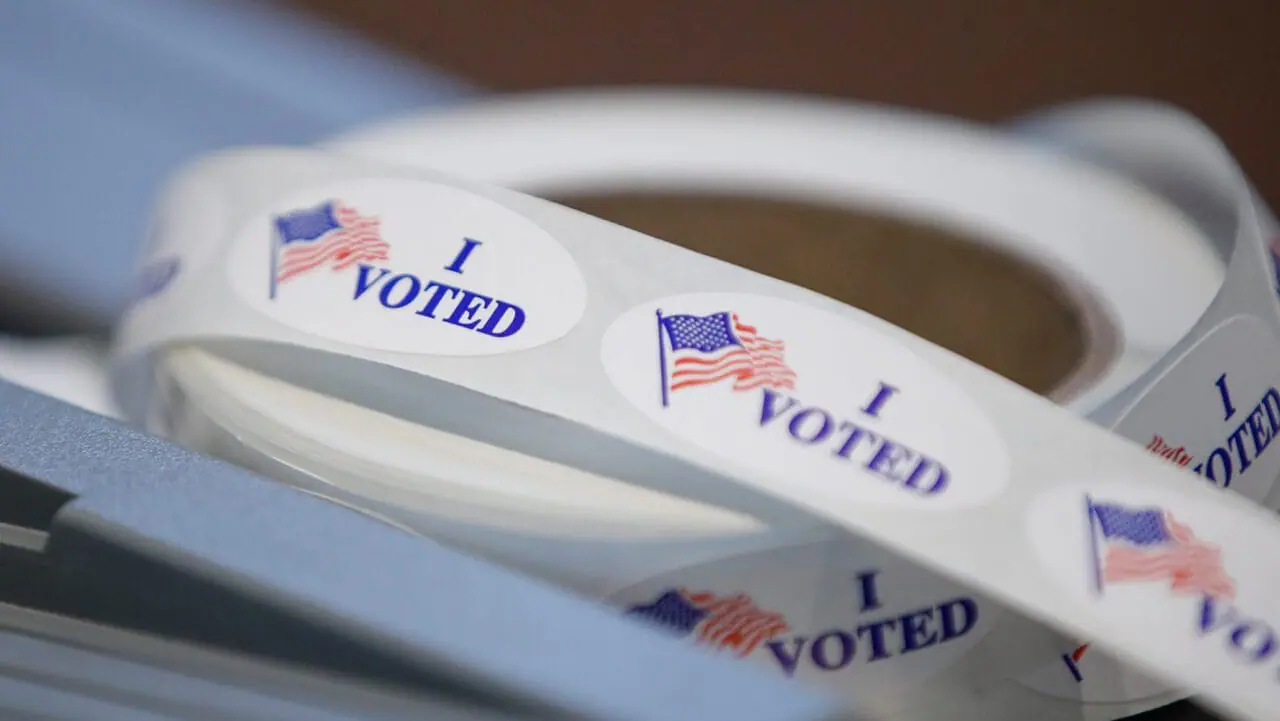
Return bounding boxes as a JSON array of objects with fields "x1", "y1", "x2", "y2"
[{"x1": 1147, "y1": 373, "x2": 1280, "y2": 488}]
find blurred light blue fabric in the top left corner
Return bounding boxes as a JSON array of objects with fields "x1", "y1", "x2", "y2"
[{"x1": 0, "y1": 0, "x2": 468, "y2": 327}]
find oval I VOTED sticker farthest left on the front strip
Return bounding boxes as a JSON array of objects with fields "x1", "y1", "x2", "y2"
[{"x1": 229, "y1": 178, "x2": 586, "y2": 356}]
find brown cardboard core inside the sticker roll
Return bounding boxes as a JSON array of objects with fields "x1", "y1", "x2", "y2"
[{"x1": 552, "y1": 191, "x2": 1103, "y2": 394}]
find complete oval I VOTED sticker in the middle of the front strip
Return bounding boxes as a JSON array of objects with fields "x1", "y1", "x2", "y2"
[{"x1": 602, "y1": 293, "x2": 1009, "y2": 510}]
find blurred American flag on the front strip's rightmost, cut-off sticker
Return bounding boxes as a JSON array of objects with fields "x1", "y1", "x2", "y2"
[{"x1": 1089, "y1": 501, "x2": 1235, "y2": 599}]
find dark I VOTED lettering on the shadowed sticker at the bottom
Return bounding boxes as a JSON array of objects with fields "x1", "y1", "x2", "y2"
[{"x1": 765, "y1": 570, "x2": 978, "y2": 676}]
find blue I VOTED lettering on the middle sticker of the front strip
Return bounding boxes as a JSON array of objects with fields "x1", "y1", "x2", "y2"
[{"x1": 760, "y1": 383, "x2": 950, "y2": 494}]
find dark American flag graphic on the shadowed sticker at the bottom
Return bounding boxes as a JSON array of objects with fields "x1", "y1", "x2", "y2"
[{"x1": 627, "y1": 588, "x2": 791, "y2": 658}]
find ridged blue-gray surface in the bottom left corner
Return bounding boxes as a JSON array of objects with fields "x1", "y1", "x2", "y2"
[{"x1": 0, "y1": 604, "x2": 535, "y2": 721}]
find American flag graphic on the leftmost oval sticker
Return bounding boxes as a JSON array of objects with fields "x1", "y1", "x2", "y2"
[{"x1": 273, "y1": 200, "x2": 390, "y2": 288}]
